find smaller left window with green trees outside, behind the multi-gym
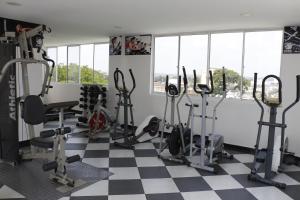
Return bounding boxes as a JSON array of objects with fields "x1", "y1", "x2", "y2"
[{"x1": 47, "y1": 43, "x2": 109, "y2": 85}]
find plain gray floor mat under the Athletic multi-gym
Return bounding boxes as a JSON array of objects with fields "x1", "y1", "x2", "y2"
[{"x1": 0, "y1": 160, "x2": 111, "y2": 200}]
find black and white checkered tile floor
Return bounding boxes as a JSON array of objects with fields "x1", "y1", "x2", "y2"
[{"x1": 0, "y1": 130, "x2": 300, "y2": 200}]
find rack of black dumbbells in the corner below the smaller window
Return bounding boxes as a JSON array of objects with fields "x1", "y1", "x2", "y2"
[{"x1": 76, "y1": 85, "x2": 107, "y2": 128}]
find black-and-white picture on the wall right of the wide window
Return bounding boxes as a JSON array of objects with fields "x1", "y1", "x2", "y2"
[{"x1": 283, "y1": 26, "x2": 300, "y2": 54}]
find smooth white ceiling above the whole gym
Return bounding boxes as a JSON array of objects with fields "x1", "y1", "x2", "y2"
[{"x1": 0, "y1": 0, "x2": 300, "y2": 45}]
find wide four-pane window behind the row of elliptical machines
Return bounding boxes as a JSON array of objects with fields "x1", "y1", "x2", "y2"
[{"x1": 153, "y1": 31, "x2": 282, "y2": 99}]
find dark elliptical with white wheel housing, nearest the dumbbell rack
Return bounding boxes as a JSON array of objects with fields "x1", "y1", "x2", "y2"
[{"x1": 111, "y1": 68, "x2": 160, "y2": 149}]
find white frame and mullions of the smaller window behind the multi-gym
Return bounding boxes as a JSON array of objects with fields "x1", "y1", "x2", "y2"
[{"x1": 46, "y1": 42, "x2": 109, "y2": 84}]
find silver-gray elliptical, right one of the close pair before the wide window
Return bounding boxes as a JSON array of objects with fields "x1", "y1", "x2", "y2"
[{"x1": 188, "y1": 67, "x2": 233, "y2": 173}]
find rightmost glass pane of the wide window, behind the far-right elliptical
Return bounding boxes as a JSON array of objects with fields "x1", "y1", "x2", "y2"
[{"x1": 243, "y1": 31, "x2": 282, "y2": 99}]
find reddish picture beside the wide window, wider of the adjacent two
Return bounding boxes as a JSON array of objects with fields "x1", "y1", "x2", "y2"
[{"x1": 125, "y1": 35, "x2": 152, "y2": 55}]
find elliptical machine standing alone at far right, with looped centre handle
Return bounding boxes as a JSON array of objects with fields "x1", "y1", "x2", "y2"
[{"x1": 248, "y1": 73, "x2": 300, "y2": 189}]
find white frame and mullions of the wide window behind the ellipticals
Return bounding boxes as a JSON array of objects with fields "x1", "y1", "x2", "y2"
[{"x1": 150, "y1": 27, "x2": 283, "y2": 101}]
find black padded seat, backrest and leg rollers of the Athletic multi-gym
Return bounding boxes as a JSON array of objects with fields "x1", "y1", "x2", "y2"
[{"x1": 22, "y1": 95, "x2": 80, "y2": 187}]
